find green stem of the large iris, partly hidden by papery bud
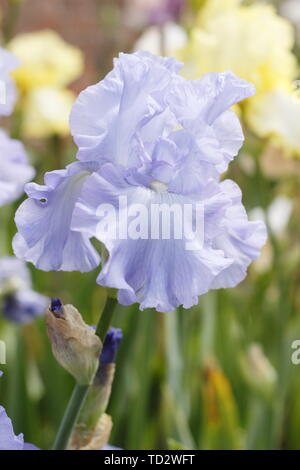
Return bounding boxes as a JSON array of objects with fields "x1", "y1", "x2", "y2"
[{"x1": 52, "y1": 297, "x2": 117, "y2": 450}]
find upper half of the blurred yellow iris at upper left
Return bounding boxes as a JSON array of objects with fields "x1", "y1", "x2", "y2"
[{"x1": 8, "y1": 30, "x2": 83, "y2": 93}]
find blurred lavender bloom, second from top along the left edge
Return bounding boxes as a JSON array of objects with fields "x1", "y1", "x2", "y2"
[{"x1": 0, "y1": 129, "x2": 35, "y2": 206}]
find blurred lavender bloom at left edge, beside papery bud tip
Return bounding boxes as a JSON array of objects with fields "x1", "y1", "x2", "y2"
[{"x1": 0, "y1": 257, "x2": 49, "y2": 323}]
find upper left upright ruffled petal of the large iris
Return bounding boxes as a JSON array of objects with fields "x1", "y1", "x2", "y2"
[{"x1": 70, "y1": 52, "x2": 181, "y2": 165}]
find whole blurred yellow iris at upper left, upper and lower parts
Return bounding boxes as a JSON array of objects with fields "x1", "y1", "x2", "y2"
[{"x1": 8, "y1": 30, "x2": 83, "y2": 138}]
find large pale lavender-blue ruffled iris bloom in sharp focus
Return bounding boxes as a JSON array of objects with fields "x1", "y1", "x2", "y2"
[{"x1": 14, "y1": 52, "x2": 266, "y2": 311}]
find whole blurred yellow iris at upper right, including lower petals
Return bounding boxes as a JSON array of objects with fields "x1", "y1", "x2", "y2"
[{"x1": 177, "y1": 0, "x2": 300, "y2": 155}]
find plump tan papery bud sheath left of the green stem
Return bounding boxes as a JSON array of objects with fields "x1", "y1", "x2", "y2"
[{"x1": 46, "y1": 305, "x2": 102, "y2": 385}]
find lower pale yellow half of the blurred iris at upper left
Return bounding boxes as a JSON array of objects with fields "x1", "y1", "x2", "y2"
[{"x1": 21, "y1": 87, "x2": 75, "y2": 138}]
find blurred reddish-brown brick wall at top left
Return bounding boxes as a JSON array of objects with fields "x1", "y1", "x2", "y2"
[{"x1": 0, "y1": 0, "x2": 138, "y2": 92}]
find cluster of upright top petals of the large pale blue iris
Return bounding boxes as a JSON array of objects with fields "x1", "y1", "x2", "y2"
[{"x1": 71, "y1": 52, "x2": 255, "y2": 173}]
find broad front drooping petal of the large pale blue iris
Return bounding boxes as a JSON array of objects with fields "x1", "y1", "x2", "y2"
[{"x1": 72, "y1": 164, "x2": 232, "y2": 312}]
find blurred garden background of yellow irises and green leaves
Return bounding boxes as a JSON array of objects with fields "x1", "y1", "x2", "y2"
[{"x1": 0, "y1": 0, "x2": 300, "y2": 449}]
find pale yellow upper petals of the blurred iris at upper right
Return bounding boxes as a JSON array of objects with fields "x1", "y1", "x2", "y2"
[{"x1": 179, "y1": 0, "x2": 297, "y2": 92}]
